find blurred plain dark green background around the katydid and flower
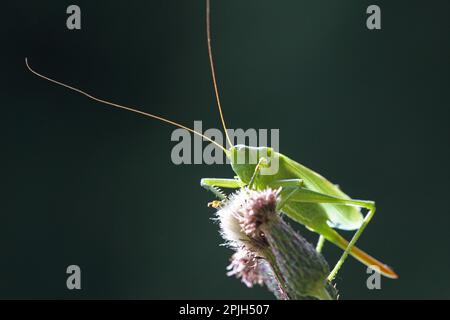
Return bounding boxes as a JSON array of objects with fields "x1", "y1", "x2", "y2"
[{"x1": 0, "y1": 0, "x2": 450, "y2": 299}]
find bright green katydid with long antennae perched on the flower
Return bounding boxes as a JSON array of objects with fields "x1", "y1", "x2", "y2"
[{"x1": 25, "y1": 0, "x2": 398, "y2": 280}]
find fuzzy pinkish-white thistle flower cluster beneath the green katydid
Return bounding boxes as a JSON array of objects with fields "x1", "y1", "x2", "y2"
[{"x1": 217, "y1": 188, "x2": 337, "y2": 299}]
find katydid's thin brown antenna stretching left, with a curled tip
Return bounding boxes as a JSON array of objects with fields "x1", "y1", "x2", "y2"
[{"x1": 25, "y1": 58, "x2": 228, "y2": 154}]
